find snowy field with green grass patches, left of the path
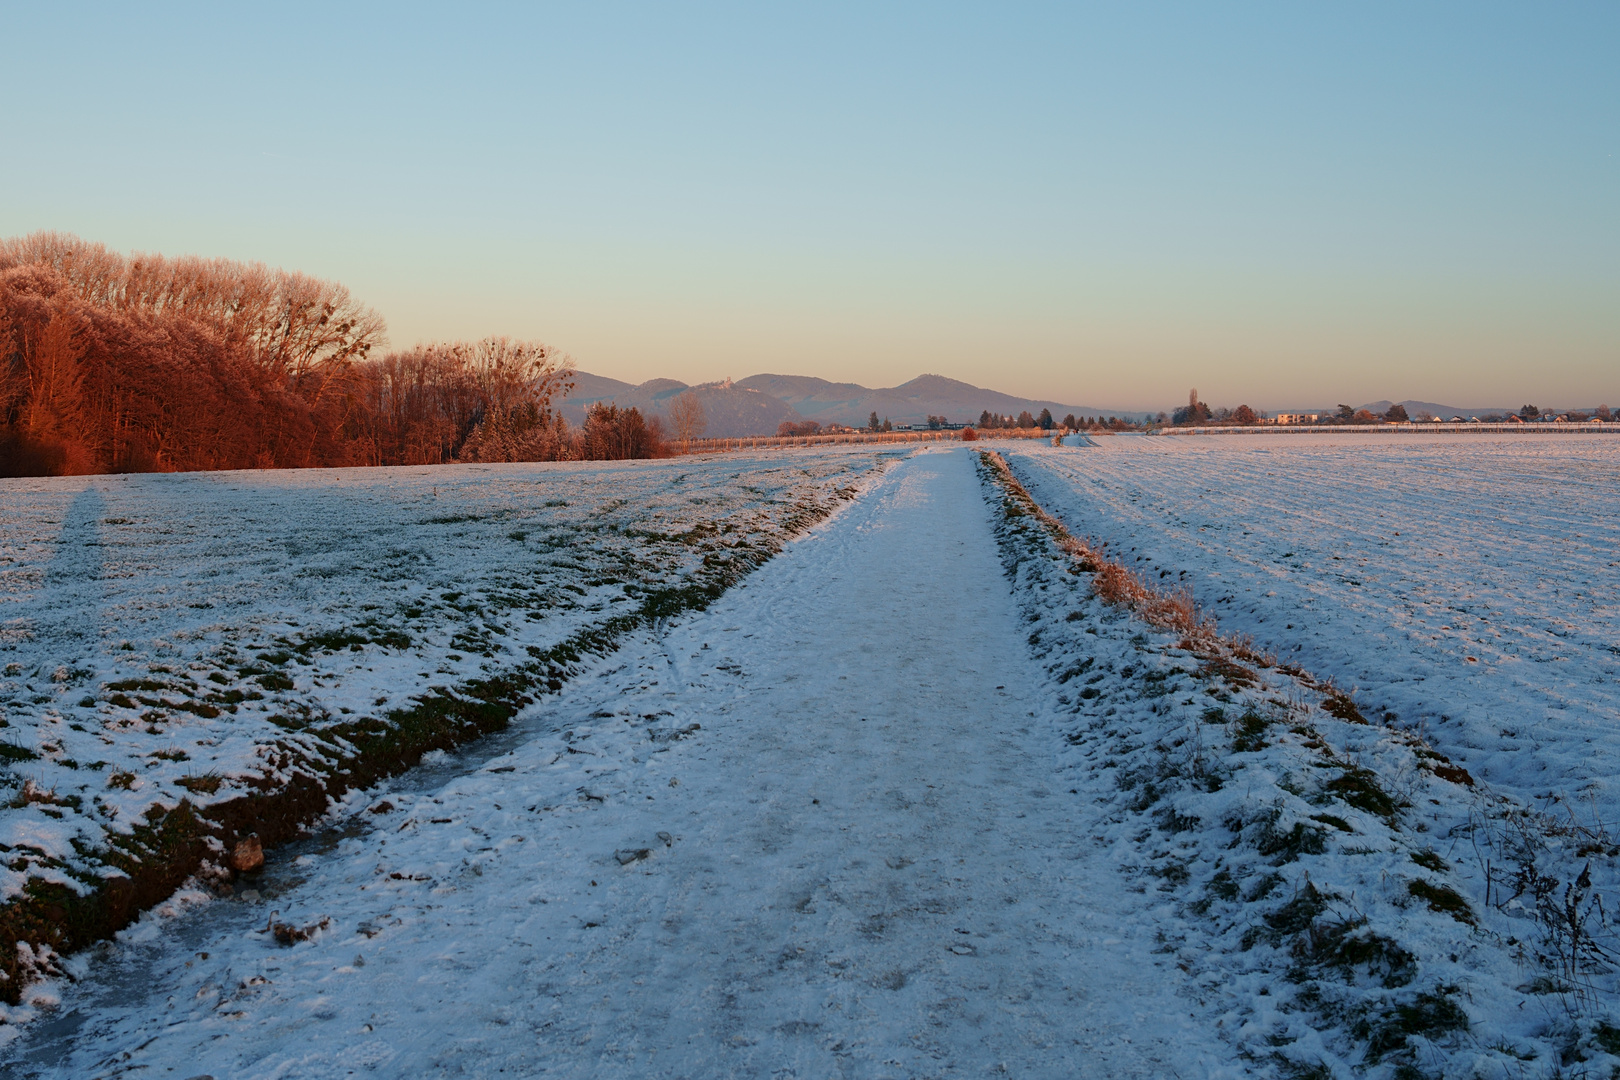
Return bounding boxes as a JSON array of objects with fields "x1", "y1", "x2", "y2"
[{"x1": 0, "y1": 452, "x2": 878, "y2": 999}]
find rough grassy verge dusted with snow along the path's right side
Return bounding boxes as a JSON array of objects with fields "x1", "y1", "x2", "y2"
[{"x1": 980, "y1": 452, "x2": 1620, "y2": 1078}]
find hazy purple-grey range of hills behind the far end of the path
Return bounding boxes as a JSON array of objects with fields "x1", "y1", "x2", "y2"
[{"x1": 559, "y1": 371, "x2": 1144, "y2": 439}]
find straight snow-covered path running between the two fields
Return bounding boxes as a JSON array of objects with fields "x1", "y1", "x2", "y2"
[{"x1": 10, "y1": 450, "x2": 1226, "y2": 1077}]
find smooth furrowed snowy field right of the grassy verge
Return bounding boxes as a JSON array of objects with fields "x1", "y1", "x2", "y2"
[{"x1": 1009, "y1": 434, "x2": 1620, "y2": 823}]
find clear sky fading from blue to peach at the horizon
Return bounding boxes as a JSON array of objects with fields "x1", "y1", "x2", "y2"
[{"x1": 0, "y1": 3, "x2": 1620, "y2": 410}]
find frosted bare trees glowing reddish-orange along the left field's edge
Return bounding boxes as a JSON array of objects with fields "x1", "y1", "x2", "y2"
[{"x1": 0, "y1": 233, "x2": 670, "y2": 476}]
